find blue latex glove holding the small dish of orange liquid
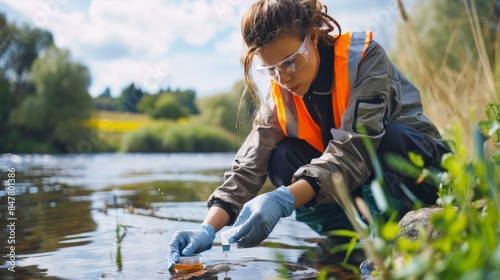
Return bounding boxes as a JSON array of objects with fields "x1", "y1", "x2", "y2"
[{"x1": 168, "y1": 224, "x2": 215, "y2": 270}]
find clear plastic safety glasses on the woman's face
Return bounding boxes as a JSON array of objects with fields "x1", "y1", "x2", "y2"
[{"x1": 255, "y1": 34, "x2": 310, "y2": 80}]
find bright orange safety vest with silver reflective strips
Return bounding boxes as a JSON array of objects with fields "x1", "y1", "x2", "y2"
[{"x1": 271, "y1": 31, "x2": 373, "y2": 152}]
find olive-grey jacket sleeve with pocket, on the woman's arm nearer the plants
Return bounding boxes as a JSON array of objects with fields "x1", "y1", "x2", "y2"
[{"x1": 294, "y1": 41, "x2": 406, "y2": 203}]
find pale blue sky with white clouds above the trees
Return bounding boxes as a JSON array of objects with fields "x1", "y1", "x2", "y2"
[{"x1": 0, "y1": 0, "x2": 413, "y2": 97}]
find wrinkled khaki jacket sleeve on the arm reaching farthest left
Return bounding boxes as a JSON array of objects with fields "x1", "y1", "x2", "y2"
[{"x1": 208, "y1": 94, "x2": 284, "y2": 219}]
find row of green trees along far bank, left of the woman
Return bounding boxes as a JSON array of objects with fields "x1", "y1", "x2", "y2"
[{"x1": 0, "y1": 13, "x2": 213, "y2": 153}]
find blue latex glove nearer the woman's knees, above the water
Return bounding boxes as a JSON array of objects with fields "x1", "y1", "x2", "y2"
[{"x1": 228, "y1": 186, "x2": 295, "y2": 247}]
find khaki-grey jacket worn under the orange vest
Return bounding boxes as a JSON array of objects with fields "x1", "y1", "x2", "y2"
[{"x1": 208, "y1": 35, "x2": 441, "y2": 218}]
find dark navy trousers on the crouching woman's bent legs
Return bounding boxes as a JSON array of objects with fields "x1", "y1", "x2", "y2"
[{"x1": 269, "y1": 123, "x2": 450, "y2": 233}]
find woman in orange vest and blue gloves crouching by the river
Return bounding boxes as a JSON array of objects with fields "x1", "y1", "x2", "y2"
[{"x1": 170, "y1": 0, "x2": 449, "y2": 267}]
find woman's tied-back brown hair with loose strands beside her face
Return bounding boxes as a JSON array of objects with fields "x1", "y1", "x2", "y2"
[{"x1": 240, "y1": 0, "x2": 341, "y2": 110}]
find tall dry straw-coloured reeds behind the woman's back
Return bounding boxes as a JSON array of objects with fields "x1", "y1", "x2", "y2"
[{"x1": 391, "y1": 0, "x2": 500, "y2": 151}]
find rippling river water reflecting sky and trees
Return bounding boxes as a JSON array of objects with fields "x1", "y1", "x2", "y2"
[{"x1": 0, "y1": 153, "x2": 356, "y2": 279}]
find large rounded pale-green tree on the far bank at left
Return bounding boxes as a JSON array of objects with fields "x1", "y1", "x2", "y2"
[{"x1": 9, "y1": 47, "x2": 92, "y2": 150}]
